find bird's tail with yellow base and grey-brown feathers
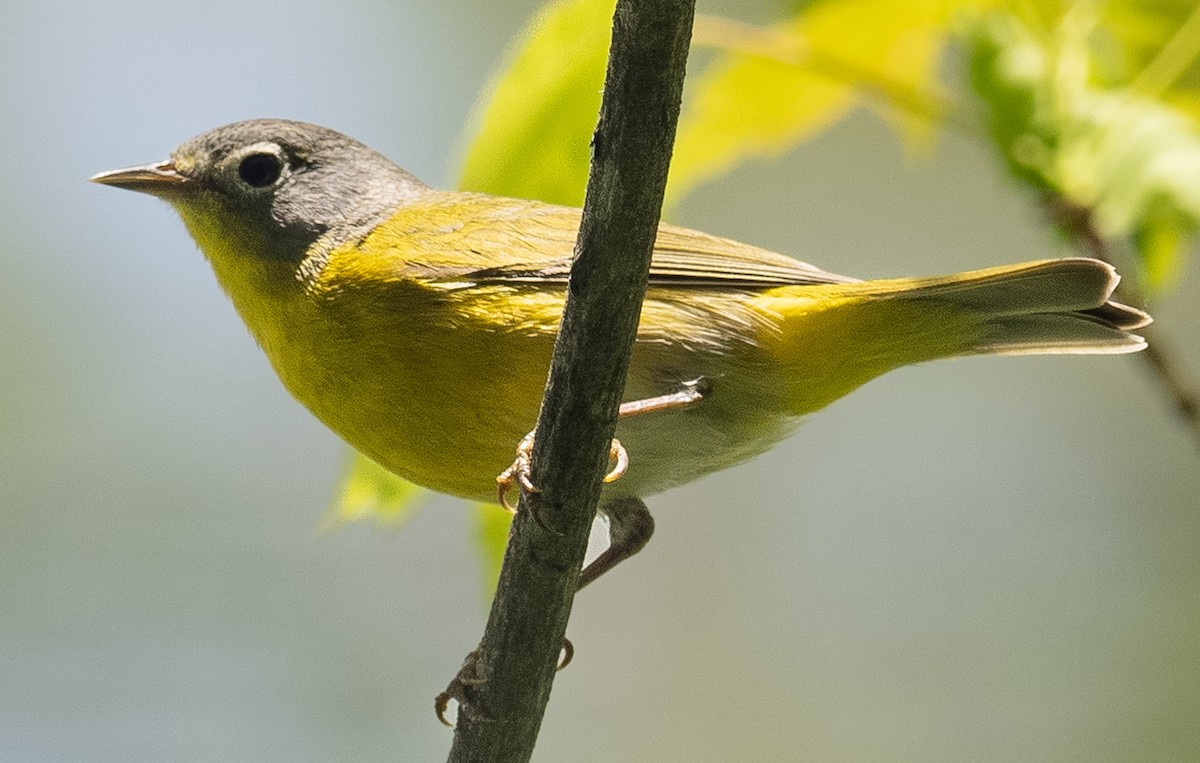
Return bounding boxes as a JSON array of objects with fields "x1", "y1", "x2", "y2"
[{"x1": 758, "y1": 258, "x2": 1150, "y2": 415}]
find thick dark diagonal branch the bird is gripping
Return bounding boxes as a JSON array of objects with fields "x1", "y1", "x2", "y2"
[{"x1": 450, "y1": 0, "x2": 694, "y2": 763}]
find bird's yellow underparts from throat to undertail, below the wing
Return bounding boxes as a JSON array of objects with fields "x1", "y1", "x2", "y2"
[{"x1": 196, "y1": 203, "x2": 979, "y2": 500}]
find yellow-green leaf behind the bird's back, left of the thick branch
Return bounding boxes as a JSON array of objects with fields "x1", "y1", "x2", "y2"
[{"x1": 458, "y1": 0, "x2": 616, "y2": 206}]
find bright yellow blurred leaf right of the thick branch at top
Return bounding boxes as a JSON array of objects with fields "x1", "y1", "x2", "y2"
[{"x1": 670, "y1": 0, "x2": 995, "y2": 198}]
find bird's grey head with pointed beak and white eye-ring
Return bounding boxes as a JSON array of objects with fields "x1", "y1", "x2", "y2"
[{"x1": 92, "y1": 119, "x2": 426, "y2": 262}]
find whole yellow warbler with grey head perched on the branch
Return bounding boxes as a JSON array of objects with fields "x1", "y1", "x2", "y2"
[{"x1": 92, "y1": 120, "x2": 1150, "y2": 587}]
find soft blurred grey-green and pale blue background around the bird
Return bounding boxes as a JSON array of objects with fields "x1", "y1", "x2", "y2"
[{"x1": 0, "y1": 0, "x2": 1200, "y2": 761}]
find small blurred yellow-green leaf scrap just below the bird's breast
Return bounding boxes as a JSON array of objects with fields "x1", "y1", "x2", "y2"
[{"x1": 320, "y1": 451, "x2": 428, "y2": 530}]
